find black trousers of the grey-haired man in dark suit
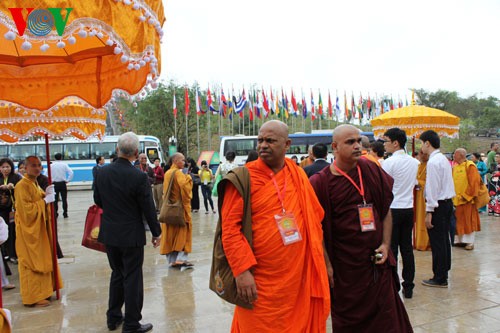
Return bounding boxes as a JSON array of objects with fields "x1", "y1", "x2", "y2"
[{"x1": 106, "y1": 245, "x2": 144, "y2": 330}]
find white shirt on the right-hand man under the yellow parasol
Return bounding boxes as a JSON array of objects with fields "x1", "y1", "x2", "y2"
[{"x1": 425, "y1": 149, "x2": 455, "y2": 212}]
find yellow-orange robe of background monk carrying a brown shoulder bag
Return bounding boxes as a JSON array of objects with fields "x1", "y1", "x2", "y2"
[{"x1": 160, "y1": 165, "x2": 193, "y2": 254}]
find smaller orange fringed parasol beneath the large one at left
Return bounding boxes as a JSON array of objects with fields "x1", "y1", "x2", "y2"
[{"x1": 0, "y1": 97, "x2": 106, "y2": 143}]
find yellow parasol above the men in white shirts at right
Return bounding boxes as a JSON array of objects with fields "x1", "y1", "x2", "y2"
[{"x1": 371, "y1": 105, "x2": 460, "y2": 138}]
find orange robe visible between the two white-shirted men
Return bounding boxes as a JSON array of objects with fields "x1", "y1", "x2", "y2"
[{"x1": 415, "y1": 163, "x2": 431, "y2": 251}]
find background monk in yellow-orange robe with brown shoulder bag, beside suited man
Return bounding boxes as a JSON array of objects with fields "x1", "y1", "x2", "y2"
[{"x1": 160, "y1": 153, "x2": 193, "y2": 268}]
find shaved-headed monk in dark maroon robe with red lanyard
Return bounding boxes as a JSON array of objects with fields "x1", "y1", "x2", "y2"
[{"x1": 310, "y1": 125, "x2": 413, "y2": 333}]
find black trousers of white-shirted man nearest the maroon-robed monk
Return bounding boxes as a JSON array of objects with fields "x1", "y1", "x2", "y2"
[{"x1": 391, "y1": 208, "x2": 415, "y2": 290}]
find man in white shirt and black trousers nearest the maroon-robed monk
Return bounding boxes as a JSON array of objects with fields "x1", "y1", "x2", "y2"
[{"x1": 382, "y1": 128, "x2": 419, "y2": 298}]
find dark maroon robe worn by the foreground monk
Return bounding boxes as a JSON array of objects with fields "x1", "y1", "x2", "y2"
[{"x1": 310, "y1": 158, "x2": 413, "y2": 333}]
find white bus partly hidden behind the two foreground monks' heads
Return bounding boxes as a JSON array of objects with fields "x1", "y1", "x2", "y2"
[{"x1": 219, "y1": 130, "x2": 375, "y2": 165}]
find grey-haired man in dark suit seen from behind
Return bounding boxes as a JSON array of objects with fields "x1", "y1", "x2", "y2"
[{"x1": 94, "y1": 132, "x2": 161, "y2": 333}]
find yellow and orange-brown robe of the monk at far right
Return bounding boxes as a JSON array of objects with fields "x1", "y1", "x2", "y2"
[{"x1": 453, "y1": 161, "x2": 481, "y2": 236}]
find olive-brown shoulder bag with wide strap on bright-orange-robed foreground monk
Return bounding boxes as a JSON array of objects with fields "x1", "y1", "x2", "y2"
[{"x1": 209, "y1": 167, "x2": 253, "y2": 309}]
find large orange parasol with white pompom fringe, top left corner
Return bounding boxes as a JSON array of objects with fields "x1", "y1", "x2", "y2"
[{"x1": 0, "y1": 0, "x2": 165, "y2": 110}]
